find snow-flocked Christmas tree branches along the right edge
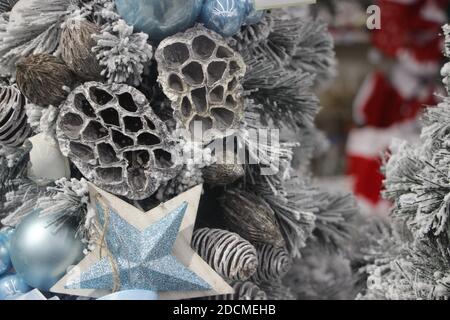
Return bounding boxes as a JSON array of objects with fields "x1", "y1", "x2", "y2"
[{"x1": 359, "y1": 26, "x2": 450, "y2": 300}]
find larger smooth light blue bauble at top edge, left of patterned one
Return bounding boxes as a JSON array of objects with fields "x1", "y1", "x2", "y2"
[{"x1": 116, "y1": 0, "x2": 203, "y2": 41}]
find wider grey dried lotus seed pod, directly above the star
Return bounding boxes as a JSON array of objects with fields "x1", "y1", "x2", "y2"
[{"x1": 57, "y1": 82, "x2": 181, "y2": 200}]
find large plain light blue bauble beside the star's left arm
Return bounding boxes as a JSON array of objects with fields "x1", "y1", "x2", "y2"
[{"x1": 10, "y1": 212, "x2": 83, "y2": 291}]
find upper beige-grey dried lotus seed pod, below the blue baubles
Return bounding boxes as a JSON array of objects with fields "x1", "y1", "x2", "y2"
[{"x1": 155, "y1": 26, "x2": 246, "y2": 141}]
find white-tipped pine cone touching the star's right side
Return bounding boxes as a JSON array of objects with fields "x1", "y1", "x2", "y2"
[{"x1": 192, "y1": 228, "x2": 258, "y2": 281}]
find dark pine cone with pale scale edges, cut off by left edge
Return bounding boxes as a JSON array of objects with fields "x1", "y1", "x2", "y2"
[{"x1": 0, "y1": 86, "x2": 32, "y2": 147}]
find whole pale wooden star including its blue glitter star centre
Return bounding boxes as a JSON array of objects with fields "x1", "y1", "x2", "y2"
[{"x1": 51, "y1": 184, "x2": 233, "y2": 300}]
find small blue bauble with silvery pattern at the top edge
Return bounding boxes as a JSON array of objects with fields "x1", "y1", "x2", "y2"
[{"x1": 200, "y1": 0, "x2": 251, "y2": 37}]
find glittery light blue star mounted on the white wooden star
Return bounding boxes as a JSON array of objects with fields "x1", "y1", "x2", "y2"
[{"x1": 66, "y1": 202, "x2": 211, "y2": 292}]
